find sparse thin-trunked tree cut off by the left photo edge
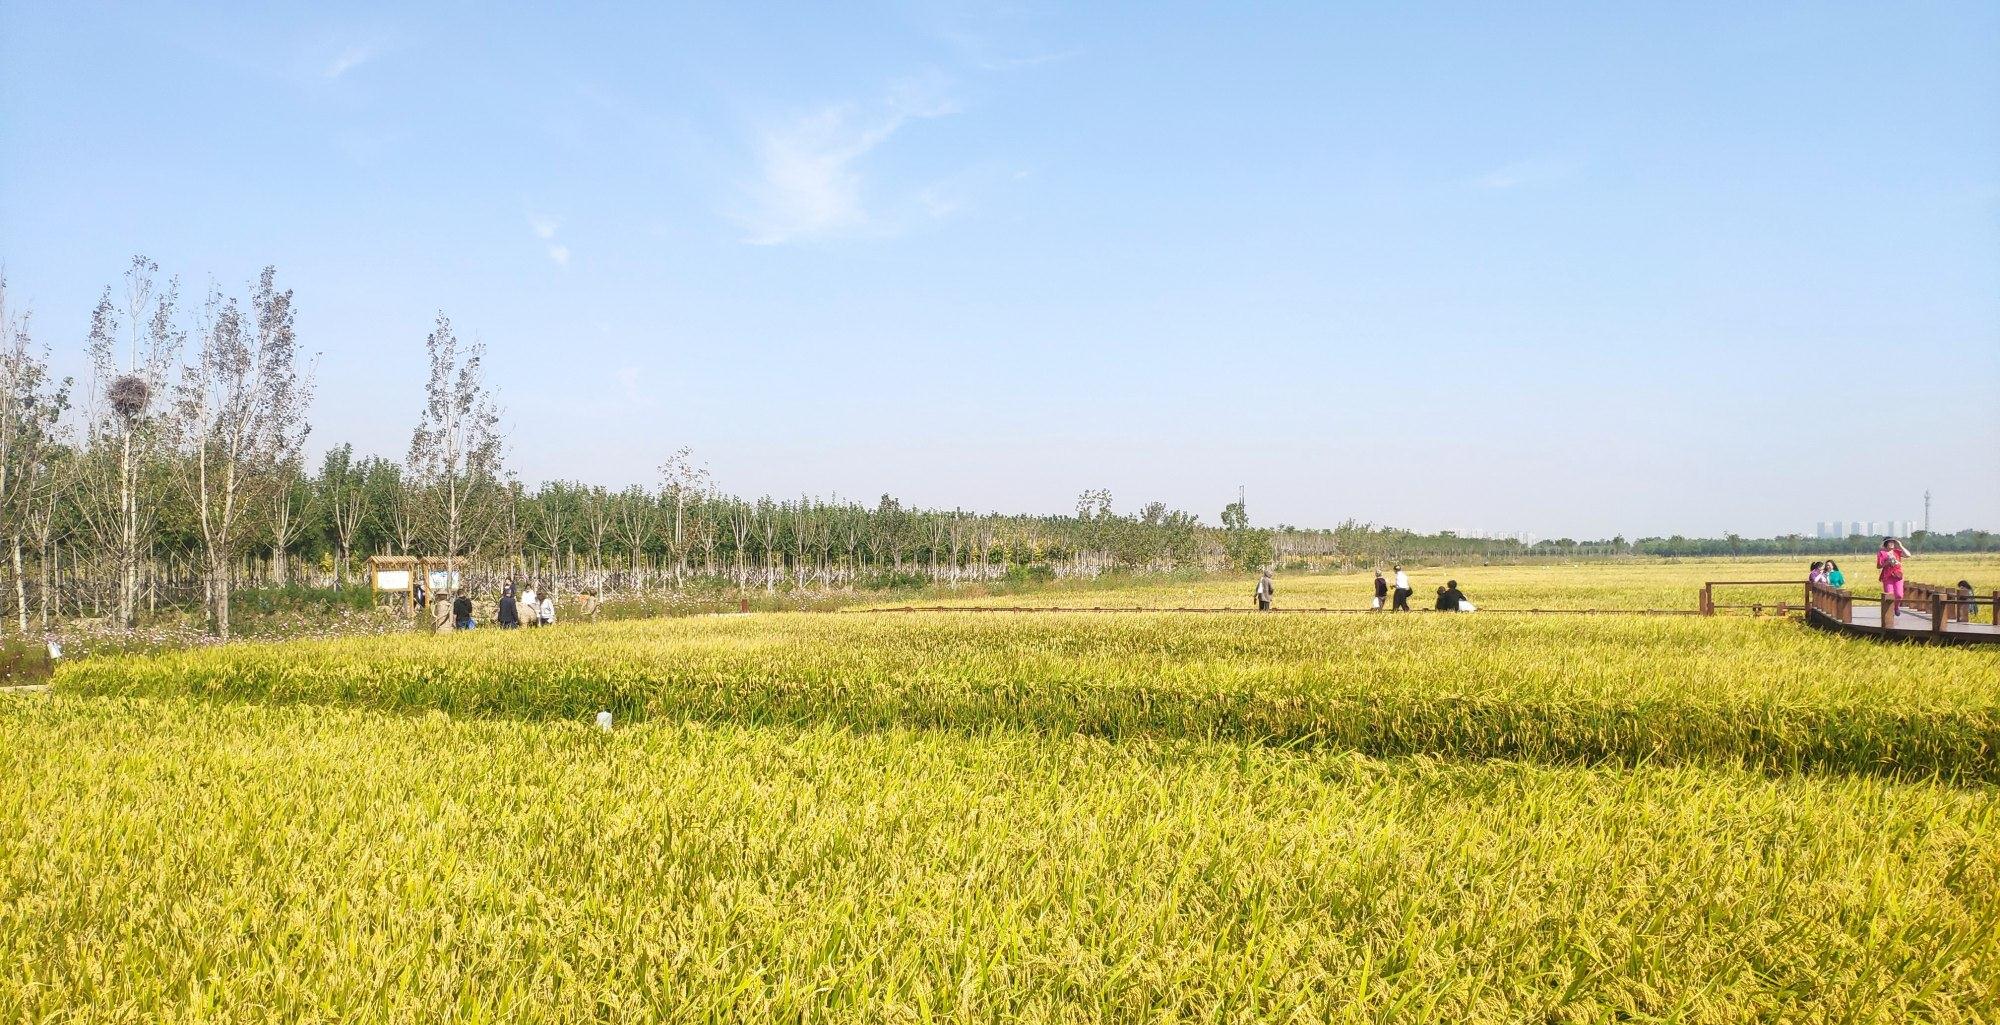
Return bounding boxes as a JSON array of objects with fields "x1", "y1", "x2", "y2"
[{"x1": 0, "y1": 274, "x2": 70, "y2": 633}]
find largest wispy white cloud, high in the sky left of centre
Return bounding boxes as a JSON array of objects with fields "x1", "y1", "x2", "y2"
[{"x1": 744, "y1": 82, "x2": 958, "y2": 246}]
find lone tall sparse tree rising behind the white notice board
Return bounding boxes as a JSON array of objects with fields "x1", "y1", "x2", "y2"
[{"x1": 408, "y1": 310, "x2": 502, "y2": 587}]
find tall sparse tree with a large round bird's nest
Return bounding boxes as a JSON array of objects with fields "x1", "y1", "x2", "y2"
[{"x1": 76, "y1": 256, "x2": 186, "y2": 629}]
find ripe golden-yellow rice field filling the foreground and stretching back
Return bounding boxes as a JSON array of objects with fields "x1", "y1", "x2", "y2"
[{"x1": 0, "y1": 559, "x2": 2000, "y2": 1023}]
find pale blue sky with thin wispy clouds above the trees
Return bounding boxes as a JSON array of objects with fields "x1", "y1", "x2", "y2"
[{"x1": 0, "y1": 0, "x2": 2000, "y2": 537}]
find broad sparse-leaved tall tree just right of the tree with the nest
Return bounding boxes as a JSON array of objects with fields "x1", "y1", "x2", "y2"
[{"x1": 174, "y1": 266, "x2": 312, "y2": 637}]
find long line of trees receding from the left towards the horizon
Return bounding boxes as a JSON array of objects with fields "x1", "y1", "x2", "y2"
[{"x1": 0, "y1": 256, "x2": 1984, "y2": 637}]
